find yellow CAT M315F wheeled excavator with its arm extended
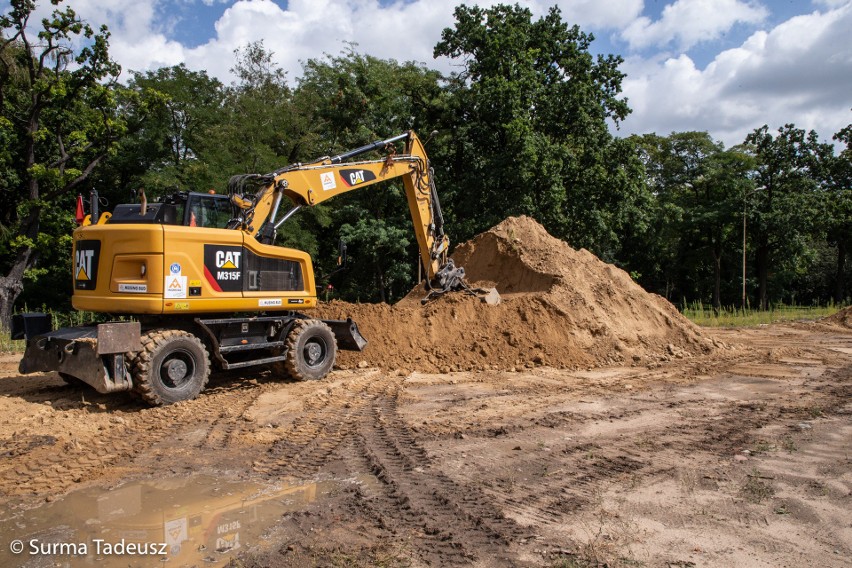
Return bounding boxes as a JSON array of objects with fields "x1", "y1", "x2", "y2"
[{"x1": 12, "y1": 131, "x2": 476, "y2": 405}]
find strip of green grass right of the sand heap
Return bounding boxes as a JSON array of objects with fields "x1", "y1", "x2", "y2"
[{"x1": 681, "y1": 302, "x2": 841, "y2": 327}]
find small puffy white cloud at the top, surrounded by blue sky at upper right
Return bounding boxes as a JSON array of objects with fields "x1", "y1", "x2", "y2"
[{"x1": 621, "y1": 0, "x2": 769, "y2": 50}]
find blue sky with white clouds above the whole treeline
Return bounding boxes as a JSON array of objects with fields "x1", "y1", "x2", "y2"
[{"x1": 8, "y1": 0, "x2": 852, "y2": 146}]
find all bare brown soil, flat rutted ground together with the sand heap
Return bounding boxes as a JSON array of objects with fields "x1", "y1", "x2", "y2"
[{"x1": 0, "y1": 218, "x2": 852, "y2": 568}]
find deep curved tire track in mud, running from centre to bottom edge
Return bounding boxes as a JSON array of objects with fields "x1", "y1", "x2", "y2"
[{"x1": 347, "y1": 384, "x2": 524, "y2": 566}]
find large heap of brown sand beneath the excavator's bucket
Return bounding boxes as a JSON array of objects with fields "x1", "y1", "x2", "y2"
[{"x1": 320, "y1": 217, "x2": 712, "y2": 372}]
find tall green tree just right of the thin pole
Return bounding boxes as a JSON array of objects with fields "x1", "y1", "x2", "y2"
[{"x1": 745, "y1": 124, "x2": 826, "y2": 310}]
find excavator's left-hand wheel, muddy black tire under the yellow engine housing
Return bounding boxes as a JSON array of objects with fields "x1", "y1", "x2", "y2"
[{"x1": 130, "y1": 329, "x2": 210, "y2": 406}]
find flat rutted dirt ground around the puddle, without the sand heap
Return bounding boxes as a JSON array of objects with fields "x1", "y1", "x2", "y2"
[{"x1": 0, "y1": 324, "x2": 852, "y2": 567}]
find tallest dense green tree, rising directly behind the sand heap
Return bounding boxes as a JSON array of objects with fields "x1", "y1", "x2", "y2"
[{"x1": 435, "y1": 5, "x2": 644, "y2": 260}]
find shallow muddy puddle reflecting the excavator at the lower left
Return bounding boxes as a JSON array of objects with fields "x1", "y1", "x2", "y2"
[{"x1": 0, "y1": 476, "x2": 340, "y2": 568}]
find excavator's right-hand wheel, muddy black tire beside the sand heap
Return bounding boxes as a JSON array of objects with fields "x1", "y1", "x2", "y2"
[{"x1": 284, "y1": 320, "x2": 337, "y2": 381}]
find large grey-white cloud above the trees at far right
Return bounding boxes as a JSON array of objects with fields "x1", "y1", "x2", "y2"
[{"x1": 624, "y1": 3, "x2": 852, "y2": 145}]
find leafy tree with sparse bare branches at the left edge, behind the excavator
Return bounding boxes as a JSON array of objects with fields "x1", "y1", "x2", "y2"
[{"x1": 0, "y1": 0, "x2": 124, "y2": 328}]
